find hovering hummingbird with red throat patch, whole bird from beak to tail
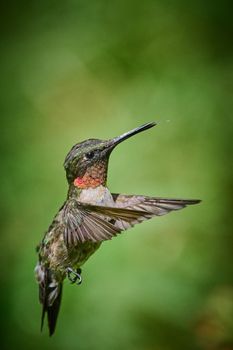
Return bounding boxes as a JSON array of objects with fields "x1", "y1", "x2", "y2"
[{"x1": 35, "y1": 122, "x2": 200, "y2": 336}]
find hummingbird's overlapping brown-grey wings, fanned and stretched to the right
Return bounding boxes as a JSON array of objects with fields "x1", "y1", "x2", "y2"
[{"x1": 63, "y1": 194, "x2": 200, "y2": 247}]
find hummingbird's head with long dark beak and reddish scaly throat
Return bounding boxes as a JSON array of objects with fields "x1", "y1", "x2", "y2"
[{"x1": 64, "y1": 123, "x2": 156, "y2": 189}]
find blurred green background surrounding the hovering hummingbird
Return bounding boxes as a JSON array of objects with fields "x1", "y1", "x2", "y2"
[{"x1": 0, "y1": 0, "x2": 233, "y2": 350}]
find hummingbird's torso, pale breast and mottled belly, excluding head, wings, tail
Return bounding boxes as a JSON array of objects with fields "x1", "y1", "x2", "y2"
[{"x1": 38, "y1": 185, "x2": 115, "y2": 282}]
